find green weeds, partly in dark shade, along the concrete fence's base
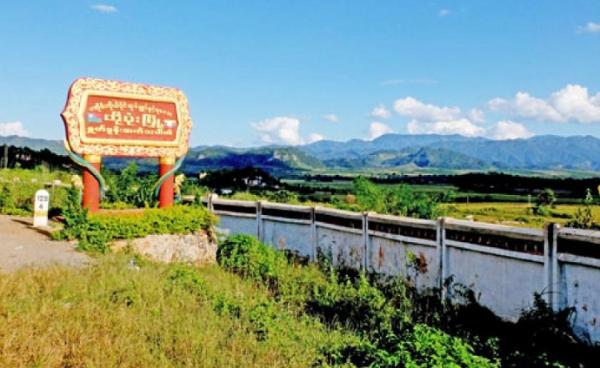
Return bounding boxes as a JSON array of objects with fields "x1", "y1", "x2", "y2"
[{"x1": 218, "y1": 235, "x2": 600, "y2": 368}]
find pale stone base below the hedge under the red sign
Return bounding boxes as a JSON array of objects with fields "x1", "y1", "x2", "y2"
[{"x1": 111, "y1": 232, "x2": 217, "y2": 265}]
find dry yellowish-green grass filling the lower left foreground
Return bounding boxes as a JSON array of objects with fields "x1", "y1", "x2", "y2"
[{"x1": 0, "y1": 254, "x2": 352, "y2": 367}]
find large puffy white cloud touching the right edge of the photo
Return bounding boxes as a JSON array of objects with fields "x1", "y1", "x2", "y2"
[{"x1": 488, "y1": 84, "x2": 600, "y2": 123}]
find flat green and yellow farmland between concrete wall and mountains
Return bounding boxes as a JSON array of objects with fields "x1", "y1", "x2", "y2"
[{"x1": 233, "y1": 175, "x2": 600, "y2": 228}]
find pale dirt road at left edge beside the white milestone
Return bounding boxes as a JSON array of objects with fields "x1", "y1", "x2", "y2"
[{"x1": 0, "y1": 215, "x2": 89, "y2": 272}]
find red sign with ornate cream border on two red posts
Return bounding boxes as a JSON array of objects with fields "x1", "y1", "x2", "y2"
[{"x1": 61, "y1": 78, "x2": 192, "y2": 212}]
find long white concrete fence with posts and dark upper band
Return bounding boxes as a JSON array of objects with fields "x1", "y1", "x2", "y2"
[{"x1": 205, "y1": 196, "x2": 600, "y2": 342}]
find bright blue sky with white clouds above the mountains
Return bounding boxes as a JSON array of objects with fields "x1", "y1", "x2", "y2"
[{"x1": 0, "y1": 0, "x2": 600, "y2": 146}]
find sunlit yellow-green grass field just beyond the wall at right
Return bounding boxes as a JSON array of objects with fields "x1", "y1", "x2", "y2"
[{"x1": 444, "y1": 202, "x2": 600, "y2": 227}]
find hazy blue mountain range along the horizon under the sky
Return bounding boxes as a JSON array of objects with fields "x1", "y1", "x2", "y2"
[{"x1": 0, "y1": 134, "x2": 600, "y2": 173}]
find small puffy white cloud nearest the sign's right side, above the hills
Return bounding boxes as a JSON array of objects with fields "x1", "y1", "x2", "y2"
[{"x1": 251, "y1": 116, "x2": 324, "y2": 146}]
